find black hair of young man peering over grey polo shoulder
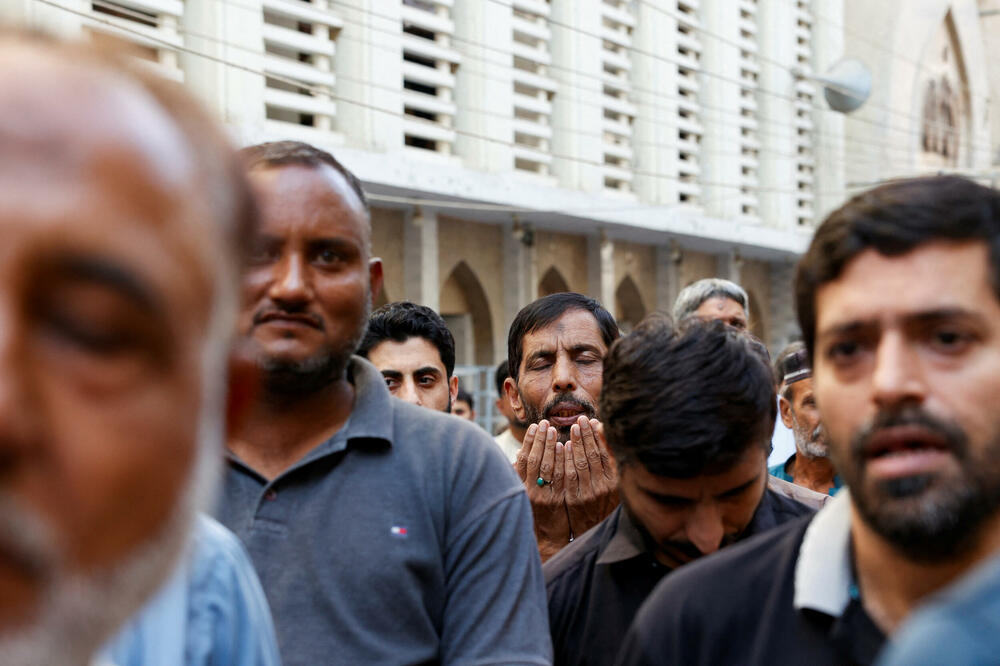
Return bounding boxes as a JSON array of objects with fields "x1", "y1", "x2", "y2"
[{"x1": 357, "y1": 301, "x2": 455, "y2": 379}]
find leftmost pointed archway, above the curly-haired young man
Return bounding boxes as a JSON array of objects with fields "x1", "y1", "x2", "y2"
[{"x1": 439, "y1": 261, "x2": 493, "y2": 365}]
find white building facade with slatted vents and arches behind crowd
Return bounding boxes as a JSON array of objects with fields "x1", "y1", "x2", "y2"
[{"x1": 7, "y1": 0, "x2": 1000, "y2": 366}]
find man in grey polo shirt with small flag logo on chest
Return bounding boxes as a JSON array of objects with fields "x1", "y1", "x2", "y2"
[{"x1": 219, "y1": 142, "x2": 551, "y2": 665}]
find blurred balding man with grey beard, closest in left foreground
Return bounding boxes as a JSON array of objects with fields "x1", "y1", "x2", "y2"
[{"x1": 0, "y1": 31, "x2": 278, "y2": 666}]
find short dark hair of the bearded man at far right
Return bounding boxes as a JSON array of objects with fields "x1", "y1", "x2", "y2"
[{"x1": 795, "y1": 176, "x2": 1000, "y2": 358}]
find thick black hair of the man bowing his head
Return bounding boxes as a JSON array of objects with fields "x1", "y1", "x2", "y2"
[{"x1": 600, "y1": 313, "x2": 777, "y2": 479}]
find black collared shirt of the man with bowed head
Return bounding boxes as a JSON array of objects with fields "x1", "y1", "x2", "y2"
[{"x1": 542, "y1": 489, "x2": 812, "y2": 665}]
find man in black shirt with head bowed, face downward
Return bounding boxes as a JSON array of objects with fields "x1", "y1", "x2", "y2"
[{"x1": 543, "y1": 314, "x2": 811, "y2": 664}]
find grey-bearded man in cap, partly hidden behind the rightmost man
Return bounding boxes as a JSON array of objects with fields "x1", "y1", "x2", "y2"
[{"x1": 768, "y1": 342, "x2": 843, "y2": 495}]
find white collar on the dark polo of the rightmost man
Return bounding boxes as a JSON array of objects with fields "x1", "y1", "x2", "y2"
[{"x1": 793, "y1": 488, "x2": 852, "y2": 617}]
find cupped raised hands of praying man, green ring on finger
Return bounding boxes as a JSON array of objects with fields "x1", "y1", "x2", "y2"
[{"x1": 515, "y1": 416, "x2": 618, "y2": 561}]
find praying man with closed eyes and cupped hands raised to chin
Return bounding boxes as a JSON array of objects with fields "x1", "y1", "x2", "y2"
[{"x1": 504, "y1": 292, "x2": 619, "y2": 562}]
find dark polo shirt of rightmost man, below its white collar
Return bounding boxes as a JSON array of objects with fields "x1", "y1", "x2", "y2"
[{"x1": 618, "y1": 518, "x2": 885, "y2": 666}]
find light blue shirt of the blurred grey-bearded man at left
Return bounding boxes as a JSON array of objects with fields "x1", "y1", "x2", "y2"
[{"x1": 100, "y1": 515, "x2": 280, "y2": 666}]
